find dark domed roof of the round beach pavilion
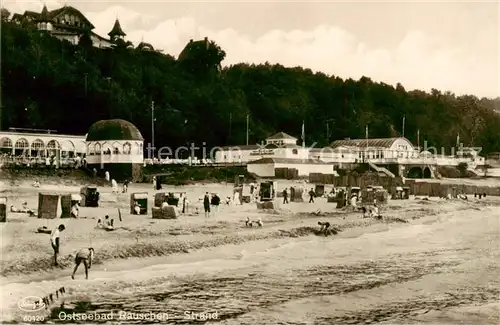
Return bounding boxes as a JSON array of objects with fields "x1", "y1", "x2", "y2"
[{"x1": 86, "y1": 119, "x2": 144, "y2": 141}]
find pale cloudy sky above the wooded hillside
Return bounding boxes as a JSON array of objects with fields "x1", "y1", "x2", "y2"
[{"x1": 3, "y1": 0, "x2": 500, "y2": 97}]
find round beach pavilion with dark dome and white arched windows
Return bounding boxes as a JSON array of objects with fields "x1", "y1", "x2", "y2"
[{"x1": 85, "y1": 119, "x2": 144, "y2": 180}]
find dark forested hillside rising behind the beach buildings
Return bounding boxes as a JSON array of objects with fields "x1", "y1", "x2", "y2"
[{"x1": 1, "y1": 23, "x2": 500, "y2": 153}]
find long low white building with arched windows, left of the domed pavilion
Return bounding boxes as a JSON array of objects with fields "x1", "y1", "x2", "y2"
[{"x1": 0, "y1": 131, "x2": 87, "y2": 157}]
